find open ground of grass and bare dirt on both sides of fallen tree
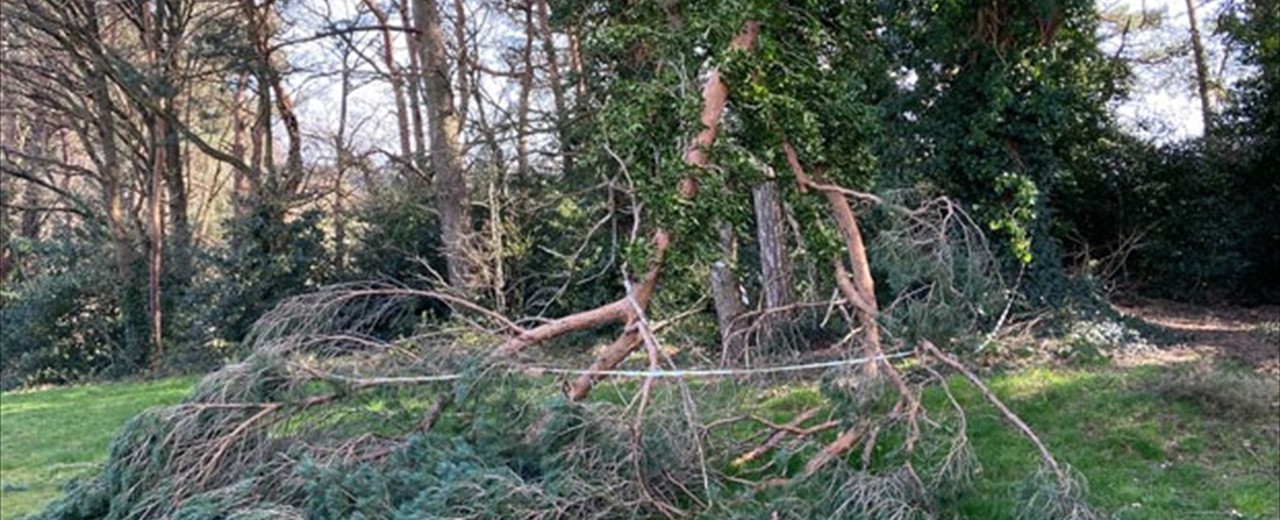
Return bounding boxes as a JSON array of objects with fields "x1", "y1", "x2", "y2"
[{"x1": 0, "y1": 301, "x2": 1280, "y2": 520}]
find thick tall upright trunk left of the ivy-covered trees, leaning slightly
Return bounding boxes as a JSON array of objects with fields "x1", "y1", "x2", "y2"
[{"x1": 413, "y1": 0, "x2": 472, "y2": 293}]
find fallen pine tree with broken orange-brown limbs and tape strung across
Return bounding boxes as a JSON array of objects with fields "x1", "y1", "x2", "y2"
[{"x1": 35, "y1": 15, "x2": 1100, "y2": 519}]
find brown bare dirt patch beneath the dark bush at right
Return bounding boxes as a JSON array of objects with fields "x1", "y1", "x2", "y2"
[{"x1": 1115, "y1": 300, "x2": 1280, "y2": 374}]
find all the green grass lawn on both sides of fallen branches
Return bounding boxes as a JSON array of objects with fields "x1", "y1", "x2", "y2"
[{"x1": 0, "y1": 365, "x2": 1280, "y2": 520}]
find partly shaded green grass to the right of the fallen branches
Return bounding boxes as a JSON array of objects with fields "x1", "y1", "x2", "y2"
[{"x1": 931, "y1": 366, "x2": 1280, "y2": 519}]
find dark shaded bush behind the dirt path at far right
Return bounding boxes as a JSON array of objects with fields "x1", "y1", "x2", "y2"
[{"x1": 1055, "y1": 134, "x2": 1280, "y2": 302}]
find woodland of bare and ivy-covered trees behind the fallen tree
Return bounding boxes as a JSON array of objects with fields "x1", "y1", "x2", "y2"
[{"x1": 0, "y1": 0, "x2": 1280, "y2": 388}]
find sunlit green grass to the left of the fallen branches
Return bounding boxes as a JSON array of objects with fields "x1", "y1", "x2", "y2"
[{"x1": 0, "y1": 378, "x2": 195, "y2": 520}]
